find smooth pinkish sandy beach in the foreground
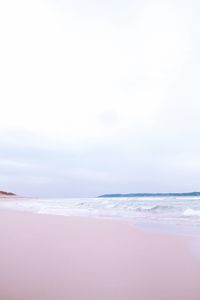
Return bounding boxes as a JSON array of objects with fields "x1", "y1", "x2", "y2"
[{"x1": 0, "y1": 210, "x2": 200, "y2": 300}]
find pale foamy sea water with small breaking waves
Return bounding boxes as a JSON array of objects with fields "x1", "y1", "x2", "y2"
[{"x1": 0, "y1": 197, "x2": 200, "y2": 236}]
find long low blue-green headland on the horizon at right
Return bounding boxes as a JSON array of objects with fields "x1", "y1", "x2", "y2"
[{"x1": 98, "y1": 192, "x2": 200, "y2": 198}]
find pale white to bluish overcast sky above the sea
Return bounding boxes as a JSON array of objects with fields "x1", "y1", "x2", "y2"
[{"x1": 0, "y1": 0, "x2": 200, "y2": 197}]
